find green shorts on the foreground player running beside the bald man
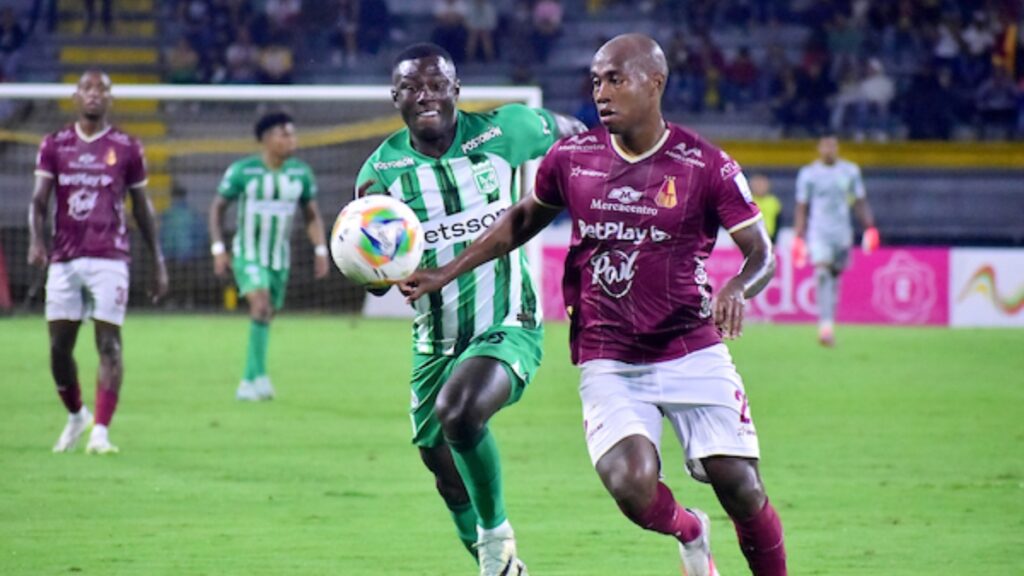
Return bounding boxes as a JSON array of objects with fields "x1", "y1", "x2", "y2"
[{"x1": 409, "y1": 326, "x2": 544, "y2": 448}]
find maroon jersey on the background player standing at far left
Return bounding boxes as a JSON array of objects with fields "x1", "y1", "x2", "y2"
[{"x1": 36, "y1": 124, "x2": 145, "y2": 262}]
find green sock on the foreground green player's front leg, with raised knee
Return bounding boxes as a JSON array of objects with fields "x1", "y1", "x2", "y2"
[{"x1": 449, "y1": 426, "x2": 508, "y2": 530}]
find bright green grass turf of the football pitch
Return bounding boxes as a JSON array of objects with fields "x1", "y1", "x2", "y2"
[{"x1": 0, "y1": 315, "x2": 1024, "y2": 576}]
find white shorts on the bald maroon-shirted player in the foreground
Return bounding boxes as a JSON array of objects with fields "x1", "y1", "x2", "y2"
[{"x1": 580, "y1": 343, "x2": 761, "y2": 482}]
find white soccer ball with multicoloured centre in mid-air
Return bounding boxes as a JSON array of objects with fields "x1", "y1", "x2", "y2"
[{"x1": 331, "y1": 195, "x2": 423, "y2": 287}]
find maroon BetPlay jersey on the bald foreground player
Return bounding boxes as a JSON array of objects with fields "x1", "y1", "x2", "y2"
[{"x1": 535, "y1": 124, "x2": 761, "y2": 364}]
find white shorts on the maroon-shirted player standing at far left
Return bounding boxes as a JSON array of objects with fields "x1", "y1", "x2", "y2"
[{"x1": 46, "y1": 258, "x2": 128, "y2": 326}]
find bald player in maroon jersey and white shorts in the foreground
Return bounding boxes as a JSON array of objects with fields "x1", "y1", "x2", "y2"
[{"x1": 399, "y1": 34, "x2": 786, "y2": 576}]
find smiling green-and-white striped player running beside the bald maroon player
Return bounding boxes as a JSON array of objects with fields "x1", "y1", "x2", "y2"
[{"x1": 356, "y1": 44, "x2": 586, "y2": 576}]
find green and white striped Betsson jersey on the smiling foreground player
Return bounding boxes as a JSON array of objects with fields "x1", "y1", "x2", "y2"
[{"x1": 355, "y1": 105, "x2": 556, "y2": 356}]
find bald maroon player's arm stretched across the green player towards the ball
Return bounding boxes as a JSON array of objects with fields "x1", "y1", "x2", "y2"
[{"x1": 398, "y1": 196, "x2": 561, "y2": 302}]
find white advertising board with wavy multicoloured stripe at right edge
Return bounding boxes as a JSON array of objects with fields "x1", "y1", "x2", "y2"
[{"x1": 949, "y1": 248, "x2": 1024, "y2": 328}]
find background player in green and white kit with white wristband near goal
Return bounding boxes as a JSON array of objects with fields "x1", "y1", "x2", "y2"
[{"x1": 210, "y1": 112, "x2": 328, "y2": 401}]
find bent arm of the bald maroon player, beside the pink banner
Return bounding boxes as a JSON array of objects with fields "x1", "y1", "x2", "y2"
[{"x1": 714, "y1": 220, "x2": 775, "y2": 338}]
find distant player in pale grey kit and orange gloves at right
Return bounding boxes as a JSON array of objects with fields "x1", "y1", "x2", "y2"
[{"x1": 793, "y1": 135, "x2": 879, "y2": 346}]
